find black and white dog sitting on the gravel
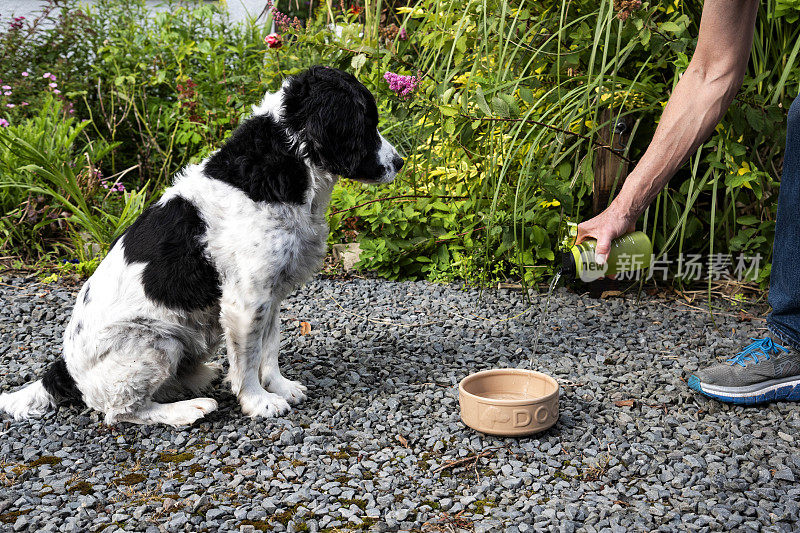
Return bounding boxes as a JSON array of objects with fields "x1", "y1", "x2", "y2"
[{"x1": 0, "y1": 67, "x2": 403, "y2": 425}]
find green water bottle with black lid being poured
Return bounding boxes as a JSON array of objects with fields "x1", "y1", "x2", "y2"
[{"x1": 561, "y1": 231, "x2": 653, "y2": 282}]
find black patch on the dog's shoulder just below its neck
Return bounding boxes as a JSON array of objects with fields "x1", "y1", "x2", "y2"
[{"x1": 205, "y1": 115, "x2": 309, "y2": 204}]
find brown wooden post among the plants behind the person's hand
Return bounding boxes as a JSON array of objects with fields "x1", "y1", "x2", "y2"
[{"x1": 592, "y1": 107, "x2": 633, "y2": 215}]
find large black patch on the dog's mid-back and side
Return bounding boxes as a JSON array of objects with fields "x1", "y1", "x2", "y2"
[{"x1": 122, "y1": 196, "x2": 222, "y2": 311}]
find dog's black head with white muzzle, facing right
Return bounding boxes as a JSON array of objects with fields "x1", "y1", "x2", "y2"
[{"x1": 281, "y1": 66, "x2": 403, "y2": 183}]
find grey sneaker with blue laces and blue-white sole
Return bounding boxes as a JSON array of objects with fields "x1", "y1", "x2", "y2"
[{"x1": 689, "y1": 337, "x2": 800, "y2": 405}]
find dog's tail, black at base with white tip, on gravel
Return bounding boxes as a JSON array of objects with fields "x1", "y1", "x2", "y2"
[{"x1": 0, "y1": 359, "x2": 83, "y2": 420}]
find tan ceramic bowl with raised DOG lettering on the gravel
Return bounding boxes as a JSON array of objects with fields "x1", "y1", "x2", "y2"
[{"x1": 458, "y1": 368, "x2": 559, "y2": 437}]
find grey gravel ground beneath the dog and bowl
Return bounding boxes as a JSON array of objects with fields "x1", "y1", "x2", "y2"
[{"x1": 0, "y1": 279, "x2": 800, "y2": 532}]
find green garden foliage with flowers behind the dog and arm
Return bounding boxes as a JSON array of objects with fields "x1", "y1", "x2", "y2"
[{"x1": 0, "y1": 0, "x2": 800, "y2": 283}]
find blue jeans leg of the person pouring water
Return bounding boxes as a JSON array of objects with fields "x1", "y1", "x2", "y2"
[{"x1": 767, "y1": 96, "x2": 800, "y2": 349}]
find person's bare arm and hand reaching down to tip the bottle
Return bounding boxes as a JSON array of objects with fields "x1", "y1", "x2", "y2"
[{"x1": 578, "y1": 0, "x2": 758, "y2": 264}]
